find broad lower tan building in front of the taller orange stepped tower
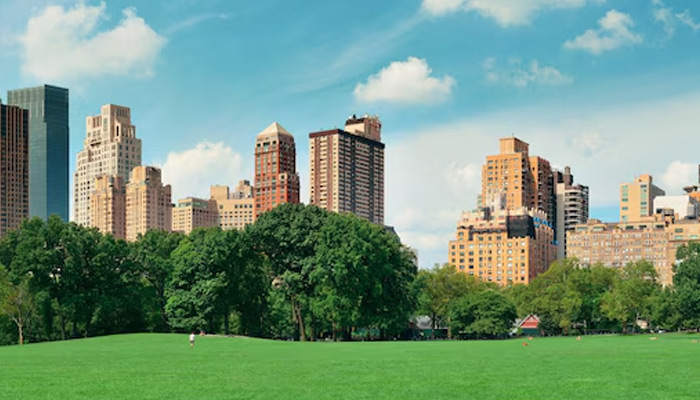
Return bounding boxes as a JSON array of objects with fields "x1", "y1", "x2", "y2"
[{"x1": 448, "y1": 207, "x2": 556, "y2": 286}]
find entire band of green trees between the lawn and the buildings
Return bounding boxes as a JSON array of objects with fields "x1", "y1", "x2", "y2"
[{"x1": 0, "y1": 204, "x2": 700, "y2": 344}]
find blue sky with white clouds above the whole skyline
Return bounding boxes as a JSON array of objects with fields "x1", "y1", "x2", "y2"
[{"x1": 0, "y1": 0, "x2": 700, "y2": 268}]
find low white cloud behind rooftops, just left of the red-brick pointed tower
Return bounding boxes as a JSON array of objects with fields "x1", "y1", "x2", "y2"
[{"x1": 161, "y1": 142, "x2": 247, "y2": 202}]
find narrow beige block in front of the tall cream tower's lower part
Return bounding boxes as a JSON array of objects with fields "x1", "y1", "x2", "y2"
[{"x1": 90, "y1": 175, "x2": 126, "y2": 239}]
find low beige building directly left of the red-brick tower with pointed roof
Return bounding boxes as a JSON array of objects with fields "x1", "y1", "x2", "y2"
[{"x1": 211, "y1": 180, "x2": 255, "y2": 230}]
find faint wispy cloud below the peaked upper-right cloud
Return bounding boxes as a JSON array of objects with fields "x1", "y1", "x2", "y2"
[{"x1": 484, "y1": 58, "x2": 574, "y2": 88}]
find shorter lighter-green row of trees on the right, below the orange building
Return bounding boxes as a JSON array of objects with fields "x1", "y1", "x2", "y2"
[{"x1": 418, "y1": 243, "x2": 700, "y2": 338}]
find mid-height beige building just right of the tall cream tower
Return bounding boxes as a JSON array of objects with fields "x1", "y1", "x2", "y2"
[{"x1": 126, "y1": 166, "x2": 173, "y2": 241}]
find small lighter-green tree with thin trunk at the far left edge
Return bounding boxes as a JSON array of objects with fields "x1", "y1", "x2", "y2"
[{"x1": 0, "y1": 266, "x2": 34, "y2": 346}]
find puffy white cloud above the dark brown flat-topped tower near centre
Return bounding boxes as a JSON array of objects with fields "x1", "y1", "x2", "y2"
[{"x1": 353, "y1": 57, "x2": 455, "y2": 104}]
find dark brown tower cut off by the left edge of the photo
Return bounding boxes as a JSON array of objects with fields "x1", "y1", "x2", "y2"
[{"x1": 0, "y1": 103, "x2": 29, "y2": 237}]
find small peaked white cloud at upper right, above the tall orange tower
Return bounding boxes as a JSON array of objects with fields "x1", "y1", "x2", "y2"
[{"x1": 564, "y1": 10, "x2": 643, "y2": 54}]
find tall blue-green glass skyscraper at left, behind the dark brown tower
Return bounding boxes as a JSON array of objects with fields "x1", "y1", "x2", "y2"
[{"x1": 7, "y1": 85, "x2": 69, "y2": 221}]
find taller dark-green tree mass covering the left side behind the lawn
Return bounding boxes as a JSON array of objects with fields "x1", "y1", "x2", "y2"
[{"x1": 0, "y1": 204, "x2": 417, "y2": 344}]
